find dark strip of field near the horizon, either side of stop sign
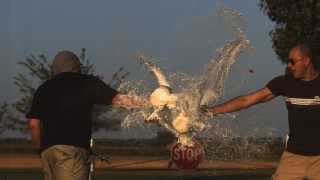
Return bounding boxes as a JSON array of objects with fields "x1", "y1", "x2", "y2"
[{"x1": 0, "y1": 135, "x2": 284, "y2": 161}]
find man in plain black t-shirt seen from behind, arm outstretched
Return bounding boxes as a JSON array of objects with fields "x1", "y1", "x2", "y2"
[{"x1": 26, "y1": 51, "x2": 147, "y2": 180}]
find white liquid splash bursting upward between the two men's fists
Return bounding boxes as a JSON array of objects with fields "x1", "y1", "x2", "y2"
[{"x1": 117, "y1": 8, "x2": 250, "y2": 146}]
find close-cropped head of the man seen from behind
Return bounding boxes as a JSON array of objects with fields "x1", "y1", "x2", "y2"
[{"x1": 52, "y1": 51, "x2": 81, "y2": 75}]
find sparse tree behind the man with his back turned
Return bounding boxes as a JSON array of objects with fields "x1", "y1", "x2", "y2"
[{"x1": 5, "y1": 48, "x2": 129, "y2": 132}]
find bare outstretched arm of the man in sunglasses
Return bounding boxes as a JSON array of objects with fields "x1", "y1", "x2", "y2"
[{"x1": 208, "y1": 88, "x2": 275, "y2": 115}]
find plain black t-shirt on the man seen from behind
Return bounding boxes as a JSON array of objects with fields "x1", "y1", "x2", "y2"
[{"x1": 27, "y1": 72, "x2": 118, "y2": 151}]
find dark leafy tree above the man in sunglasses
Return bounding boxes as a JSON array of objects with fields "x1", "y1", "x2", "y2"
[{"x1": 259, "y1": 0, "x2": 320, "y2": 66}]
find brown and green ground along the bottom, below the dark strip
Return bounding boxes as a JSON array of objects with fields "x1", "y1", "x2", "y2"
[{"x1": 0, "y1": 154, "x2": 277, "y2": 180}]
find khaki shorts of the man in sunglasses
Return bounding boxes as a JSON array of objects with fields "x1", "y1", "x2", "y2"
[{"x1": 272, "y1": 151, "x2": 320, "y2": 180}]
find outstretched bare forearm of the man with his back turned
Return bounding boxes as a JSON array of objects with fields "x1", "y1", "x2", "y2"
[{"x1": 112, "y1": 94, "x2": 150, "y2": 108}]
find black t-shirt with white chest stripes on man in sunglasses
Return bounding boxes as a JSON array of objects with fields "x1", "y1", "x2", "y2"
[{"x1": 267, "y1": 76, "x2": 320, "y2": 155}]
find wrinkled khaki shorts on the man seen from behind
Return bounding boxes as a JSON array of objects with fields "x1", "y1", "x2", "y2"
[{"x1": 41, "y1": 145, "x2": 90, "y2": 180}]
